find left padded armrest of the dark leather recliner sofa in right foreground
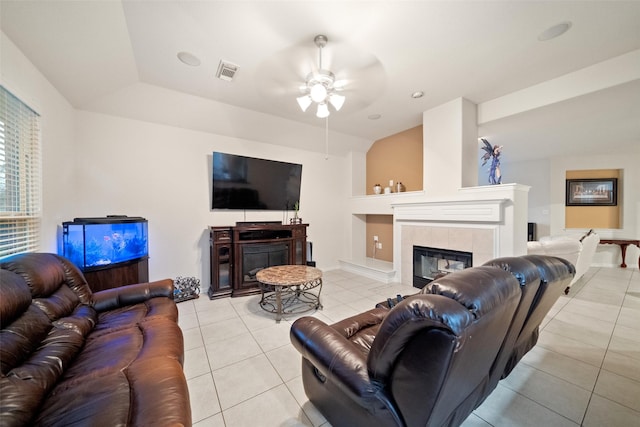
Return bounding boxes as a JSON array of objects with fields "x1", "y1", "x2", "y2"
[{"x1": 289, "y1": 317, "x2": 379, "y2": 406}]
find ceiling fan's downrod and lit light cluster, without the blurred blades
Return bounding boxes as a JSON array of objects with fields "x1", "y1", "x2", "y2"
[{"x1": 296, "y1": 34, "x2": 346, "y2": 119}]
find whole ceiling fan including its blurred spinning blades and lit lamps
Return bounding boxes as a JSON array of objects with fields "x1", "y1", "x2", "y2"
[{"x1": 255, "y1": 33, "x2": 386, "y2": 124}]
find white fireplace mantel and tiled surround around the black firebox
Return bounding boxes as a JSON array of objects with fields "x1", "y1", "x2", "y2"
[{"x1": 392, "y1": 184, "x2": 529, "y2": 285}]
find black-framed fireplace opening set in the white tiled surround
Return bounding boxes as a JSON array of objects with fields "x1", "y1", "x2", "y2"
[{"x1": 413, "y1": 246, "x2": 472, "y2": 289}]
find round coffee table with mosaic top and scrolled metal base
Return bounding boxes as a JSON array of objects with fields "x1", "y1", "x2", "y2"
[{"x1": 256, "y1": 265, "x2": 322, "y2": 323}]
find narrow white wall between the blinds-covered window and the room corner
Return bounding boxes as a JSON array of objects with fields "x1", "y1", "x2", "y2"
[{"x1": 0, "y1": 33, "x2": 77, "y2": 252}]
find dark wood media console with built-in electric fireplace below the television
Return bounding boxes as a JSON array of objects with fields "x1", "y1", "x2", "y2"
[{"x1": 209, "y1": 222, "x2": 309, "y2": 299}]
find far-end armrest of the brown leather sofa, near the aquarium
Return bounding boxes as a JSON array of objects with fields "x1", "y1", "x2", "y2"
[{"x1": 93, "y1": 279, "x2": 173, "y2": 311}]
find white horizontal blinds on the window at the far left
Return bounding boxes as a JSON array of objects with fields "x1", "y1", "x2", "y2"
[{"x1": 0, "y1": 86, "x2": 42, "y2": 258}]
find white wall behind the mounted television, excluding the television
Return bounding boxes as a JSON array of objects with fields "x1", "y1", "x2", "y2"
[{"x1": 74, "y1": 111, "x2": 350, "y2": 288}]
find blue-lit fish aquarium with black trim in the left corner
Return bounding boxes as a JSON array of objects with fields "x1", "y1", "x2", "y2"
[{"x1": 62, "y1": 215, "x2": 149, "y2": 271}]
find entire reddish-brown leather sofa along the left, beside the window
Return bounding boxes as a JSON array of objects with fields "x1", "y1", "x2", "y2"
[{"x1": 0, "y1": 253, "x2": 191, "y2": 427}]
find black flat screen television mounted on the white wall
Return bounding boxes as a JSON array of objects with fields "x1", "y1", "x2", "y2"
[{"x1": 211, "y1": 151, "x2": 302, "y2": 211}]
